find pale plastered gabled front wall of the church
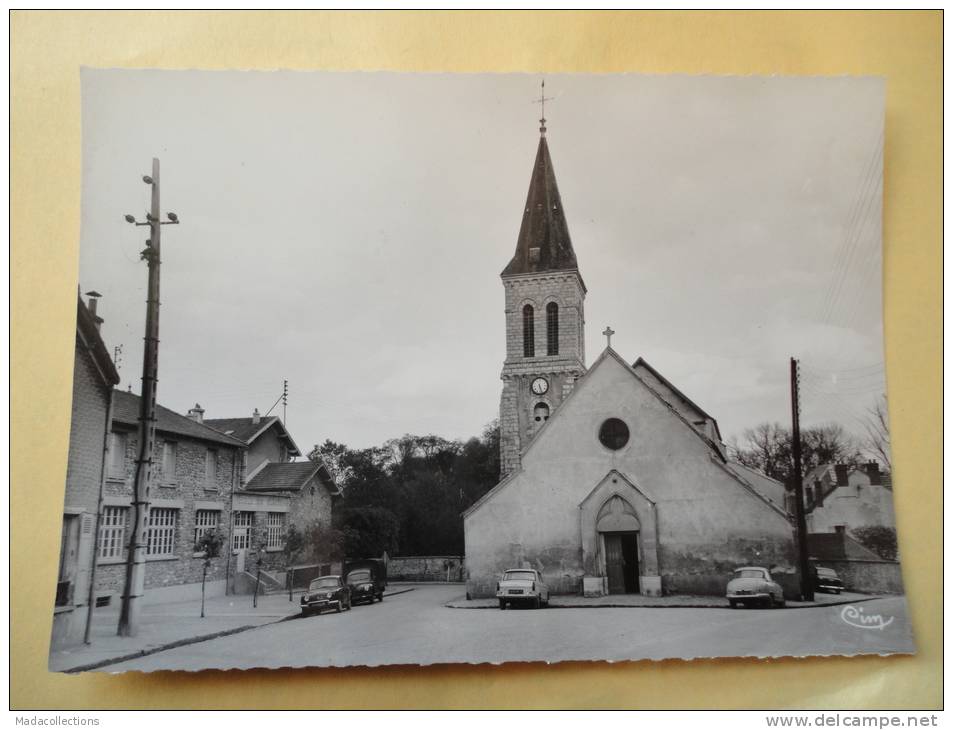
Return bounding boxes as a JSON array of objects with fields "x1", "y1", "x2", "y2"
[{"x1": 464, "y1": 353, "x2": 795, "y2": 597}]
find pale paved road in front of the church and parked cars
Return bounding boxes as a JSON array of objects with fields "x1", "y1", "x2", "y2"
[{"x1": 103, "y1": 586, "x2": 913, "y2": 672}]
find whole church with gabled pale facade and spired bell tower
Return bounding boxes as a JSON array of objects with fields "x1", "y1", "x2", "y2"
[{"x1": 464, "y1": 109, "x2": 797, "y2": 598}]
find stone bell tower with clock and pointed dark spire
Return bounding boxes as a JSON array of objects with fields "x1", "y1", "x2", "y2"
[{"x1": 500, "y1": 105, "x2": 586, "y2": 478}]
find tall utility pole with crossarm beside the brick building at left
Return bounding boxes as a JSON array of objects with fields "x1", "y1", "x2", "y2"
[{"x1": 118, "y1": 157, "x2": 179, "y2": 636}]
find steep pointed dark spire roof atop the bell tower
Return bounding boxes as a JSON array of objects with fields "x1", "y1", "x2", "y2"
[{"x1": 502, "y1": 134, "x2": 579, "y2": 276}]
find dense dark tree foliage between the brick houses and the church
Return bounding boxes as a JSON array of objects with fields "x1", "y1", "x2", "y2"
[{"x1": 309, "y1": 421, "x2": 500, "y2": 558}]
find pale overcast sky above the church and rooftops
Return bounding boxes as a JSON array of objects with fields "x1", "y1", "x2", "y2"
[{"x1": 80, "y1": 69, "x2": 884, "y2": 450}]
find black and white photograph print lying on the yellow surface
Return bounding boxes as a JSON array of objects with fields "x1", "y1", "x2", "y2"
[{"x1": 48, "y1": 68, "x2": 916, "y2": 673}]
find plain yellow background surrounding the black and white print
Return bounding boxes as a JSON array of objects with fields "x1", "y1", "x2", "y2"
[{"x1": 10, "y1": 11, "x2": 942, "y2": 708}]
